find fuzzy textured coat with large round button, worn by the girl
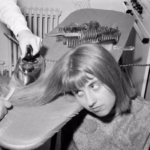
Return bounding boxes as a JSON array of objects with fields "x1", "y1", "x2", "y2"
[{"x1": 62, "y1": 97, "x2": 150, "y2": 150}]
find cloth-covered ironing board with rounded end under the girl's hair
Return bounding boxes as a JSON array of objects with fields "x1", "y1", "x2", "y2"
[{"x1": 0, "y1": 9, "x2": 134, "y2": 150}]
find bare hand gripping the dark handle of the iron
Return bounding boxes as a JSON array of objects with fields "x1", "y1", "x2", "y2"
[{"x1": 17, "y1": 30, "x2": 42, "y2": 58}]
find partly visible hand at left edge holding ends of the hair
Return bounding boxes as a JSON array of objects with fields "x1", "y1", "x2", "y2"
[{"x1": 0, "y1": 98, "x2": 11, "y2": 120}]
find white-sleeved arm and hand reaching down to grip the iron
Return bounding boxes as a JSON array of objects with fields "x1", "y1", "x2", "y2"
[{"x1": 0, "y1": 0, "x2": 42, "y2": 58}]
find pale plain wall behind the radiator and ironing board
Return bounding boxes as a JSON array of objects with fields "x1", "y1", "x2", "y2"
[{"x1": 0, "y1": 0, "x2": 123, "y2": 67}]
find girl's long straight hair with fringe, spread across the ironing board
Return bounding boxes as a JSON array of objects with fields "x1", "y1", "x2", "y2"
[{"x1": 0, "y1": 44, "x2": 136, "y2": 112}]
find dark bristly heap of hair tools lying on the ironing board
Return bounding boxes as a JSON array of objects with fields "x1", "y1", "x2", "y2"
[{"x1": 47, "y1": 21, "x2": 121, "y2": 48}]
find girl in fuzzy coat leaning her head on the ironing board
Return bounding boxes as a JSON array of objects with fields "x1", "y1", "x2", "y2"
[{"x1": 46, "y1": 44, "x2": 150, "y2": 150}]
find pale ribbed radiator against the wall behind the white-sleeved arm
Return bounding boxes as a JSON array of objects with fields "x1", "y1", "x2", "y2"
[{"x1": 8, "y1": 7, "x2": 61, "y2": 76}]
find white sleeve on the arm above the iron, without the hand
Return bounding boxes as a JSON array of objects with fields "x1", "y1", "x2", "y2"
[{"x1": 0, "y1": 0, "x2": 29, "y2": 35}]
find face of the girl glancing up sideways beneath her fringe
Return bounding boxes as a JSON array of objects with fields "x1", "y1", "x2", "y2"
[{"x1": 73, "y1": 74, "x2": 116, "y2": 117}]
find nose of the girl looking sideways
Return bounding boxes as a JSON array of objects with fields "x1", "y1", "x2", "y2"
[{"x1": 86, "y1": 92, "x2": 97, "y2": 107}]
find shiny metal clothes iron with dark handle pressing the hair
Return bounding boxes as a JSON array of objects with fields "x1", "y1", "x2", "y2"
[{"x1": 14, "y1": 45, "x2": 45, "y2": 86}]
